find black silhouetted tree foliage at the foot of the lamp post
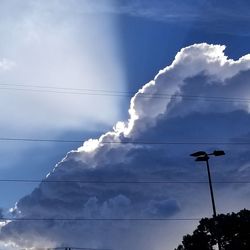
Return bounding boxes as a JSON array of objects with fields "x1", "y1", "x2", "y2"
[{"x1": 175, "y1": 209, "x2": 250, "y2": 250}]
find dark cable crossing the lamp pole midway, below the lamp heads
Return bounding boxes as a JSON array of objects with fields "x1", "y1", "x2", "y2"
[{"x1": 0, "y1": 179, "x2": 250, "y2": 184}]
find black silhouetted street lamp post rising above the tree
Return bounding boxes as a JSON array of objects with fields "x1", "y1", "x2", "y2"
[{"x1": 190, "y1": 150, "x2": 225, "y2": 250}]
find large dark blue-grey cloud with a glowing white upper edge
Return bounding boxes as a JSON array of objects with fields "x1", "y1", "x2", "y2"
[{"x1": 0, "y1": 43, "x2": 250, "y2": 250}]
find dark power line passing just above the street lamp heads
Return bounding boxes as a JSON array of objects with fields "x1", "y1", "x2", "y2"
[{"x1": 0, "y1": 137, "x2": 250, "y2": 145}]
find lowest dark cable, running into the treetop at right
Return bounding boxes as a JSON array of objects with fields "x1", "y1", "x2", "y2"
[{"x1": 0, "y1": 217, "x2": 201, "y2": 221}]
